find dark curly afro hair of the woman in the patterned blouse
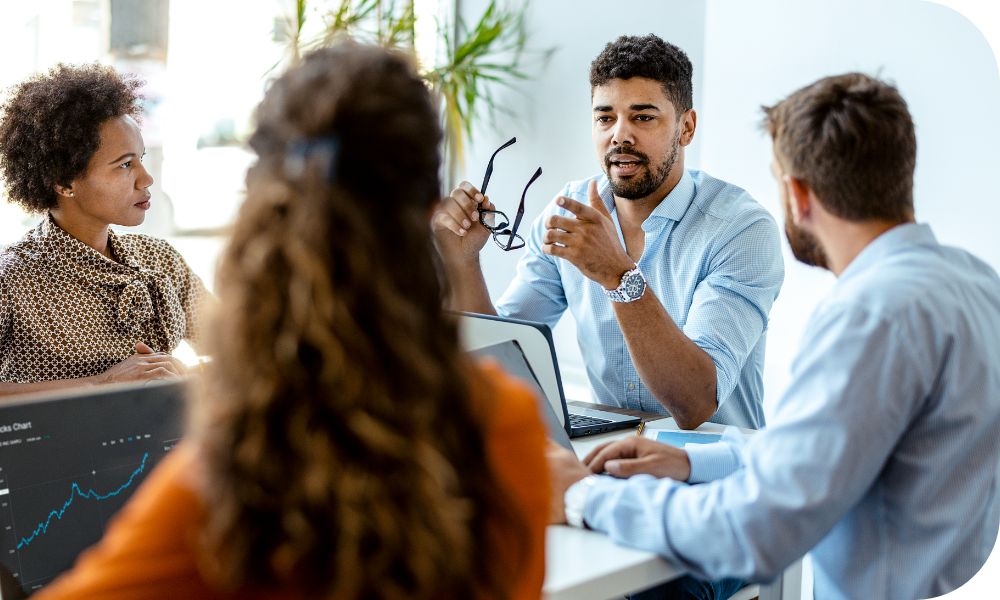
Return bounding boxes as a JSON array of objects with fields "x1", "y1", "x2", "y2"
[{"x1": 0, "y1": 63, "x2": 142, "y2": 212}]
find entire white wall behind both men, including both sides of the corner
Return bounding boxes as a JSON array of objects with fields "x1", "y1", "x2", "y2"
[{"x1": 460, "y1": 0, "x2": 1000, "y2": 418}]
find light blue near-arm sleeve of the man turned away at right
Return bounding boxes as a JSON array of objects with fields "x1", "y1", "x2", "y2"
[{"x1": 584, "y1": 302, "x2": 928, "y2": 580}]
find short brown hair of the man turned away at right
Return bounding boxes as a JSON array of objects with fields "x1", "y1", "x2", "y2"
[{"x1": 763, "y1": 73, "x2": 917, "y2": 222}]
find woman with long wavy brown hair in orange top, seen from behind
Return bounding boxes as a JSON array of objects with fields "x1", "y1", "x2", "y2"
[{"x1": 40, "y1": 44, "x2": 548, "y2": 598}]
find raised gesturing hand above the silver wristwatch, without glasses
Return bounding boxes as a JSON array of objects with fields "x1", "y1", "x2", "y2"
[{"x1": 542, "y1": 181, "x2": 635, "y2": 290}]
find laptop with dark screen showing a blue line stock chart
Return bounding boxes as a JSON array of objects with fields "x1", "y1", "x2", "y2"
[{"x1": 0, "y1": 381, "x2": 184, "y2": 600}]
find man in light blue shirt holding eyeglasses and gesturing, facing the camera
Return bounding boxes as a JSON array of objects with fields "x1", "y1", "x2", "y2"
[{"x1": 434, "y1": 35, "x2": 784, "y2": 428}]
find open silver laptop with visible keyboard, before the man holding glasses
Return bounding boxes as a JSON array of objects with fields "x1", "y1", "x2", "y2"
[{"x1": 457, "y1": 312, "x2": 641, "y2": 437}]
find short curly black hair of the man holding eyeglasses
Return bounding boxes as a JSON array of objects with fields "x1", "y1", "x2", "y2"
[{"x1": 590, "y1": 33, "x2": 694, "y2": 117}]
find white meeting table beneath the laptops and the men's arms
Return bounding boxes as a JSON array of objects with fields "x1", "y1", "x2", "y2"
[{"x1": 542, "y1": 419, "x2": 801, "y2": 600}]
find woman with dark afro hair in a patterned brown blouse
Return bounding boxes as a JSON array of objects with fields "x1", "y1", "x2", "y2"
[{"x1": 0, "y1": 64, "x2": 207, "y2": 395}]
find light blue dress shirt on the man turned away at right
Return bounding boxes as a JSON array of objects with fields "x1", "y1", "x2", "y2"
[{"x1": 585, "y1": 224, "x2": 1000, "y2": 599}]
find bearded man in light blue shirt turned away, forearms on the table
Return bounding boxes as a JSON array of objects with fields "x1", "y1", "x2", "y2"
[{"x1": 550, "y1": 74, "x2": 1000, "y2": 599}]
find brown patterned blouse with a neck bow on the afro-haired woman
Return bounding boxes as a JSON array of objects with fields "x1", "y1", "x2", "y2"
[{"x1": 0, "y1": 215, "x2": 208, "y2": 383}]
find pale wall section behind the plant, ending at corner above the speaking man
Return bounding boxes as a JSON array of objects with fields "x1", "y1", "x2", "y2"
[{"x1": 458, "y1": 0, "x2": 705, "y2": 398}]
